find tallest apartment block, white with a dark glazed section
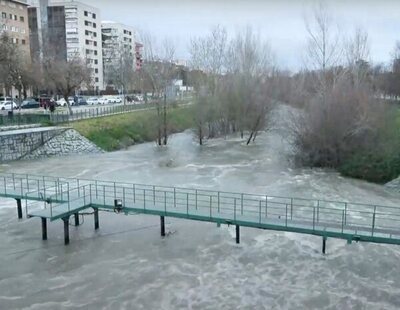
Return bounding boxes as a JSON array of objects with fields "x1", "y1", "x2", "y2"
[{"x1": 29, "y1": 0, "x2": 104, "y2": 91}]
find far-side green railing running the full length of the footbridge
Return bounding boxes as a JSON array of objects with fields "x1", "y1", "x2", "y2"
[{"x1": 0, "y1": 174, "x2": 400, "y2": 239}]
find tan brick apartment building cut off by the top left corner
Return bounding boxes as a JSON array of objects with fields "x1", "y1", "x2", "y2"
[{"x1": 0, "y1": 0, "x2": 30, "y2": 55}]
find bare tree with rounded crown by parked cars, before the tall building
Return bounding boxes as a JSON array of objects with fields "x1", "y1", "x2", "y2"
[{"x1": 43, "y1": 55, "x2": 92, "y2": 115}]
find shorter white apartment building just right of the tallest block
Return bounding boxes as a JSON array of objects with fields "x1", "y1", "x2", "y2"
[{"x1": 101, "y1": 21, "x2": 137, "y2": 87}]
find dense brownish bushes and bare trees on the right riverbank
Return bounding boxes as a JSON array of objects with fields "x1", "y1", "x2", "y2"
[{"x1": 283, "y1": 5, "x2": 400, "y2": 183}]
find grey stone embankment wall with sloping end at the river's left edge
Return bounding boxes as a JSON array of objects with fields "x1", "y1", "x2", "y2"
[{"x1": 0, "y1": 127, "x2": 103, "y2": 162}]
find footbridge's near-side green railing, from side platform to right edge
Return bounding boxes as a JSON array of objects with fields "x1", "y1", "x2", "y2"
[{"x1": 85, "y1": 181, "x2": 400, "y2": 239}]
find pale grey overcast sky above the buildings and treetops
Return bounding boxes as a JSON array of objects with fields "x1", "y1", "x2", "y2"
[{"x1": 80, "y1": 0, "x2": 400, "y2": 70}]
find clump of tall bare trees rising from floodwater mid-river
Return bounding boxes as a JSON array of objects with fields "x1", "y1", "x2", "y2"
[{"x1": 190, "y1": 26, "x2": 273, "y2": 144}]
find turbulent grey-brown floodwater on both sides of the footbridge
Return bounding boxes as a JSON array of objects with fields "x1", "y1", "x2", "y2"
[{"x1": 0, "y1": 105, "x2": 400, "y2": 310}]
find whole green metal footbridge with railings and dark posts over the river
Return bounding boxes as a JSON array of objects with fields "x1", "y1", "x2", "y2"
[{"x1": 0, "y1": 174, "x2": 400, "y2": 253}]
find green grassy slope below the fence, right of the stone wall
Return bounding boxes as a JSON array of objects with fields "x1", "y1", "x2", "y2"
[{"x1": 71, "y1": 106, "x2": 197, "y2": 151}]
